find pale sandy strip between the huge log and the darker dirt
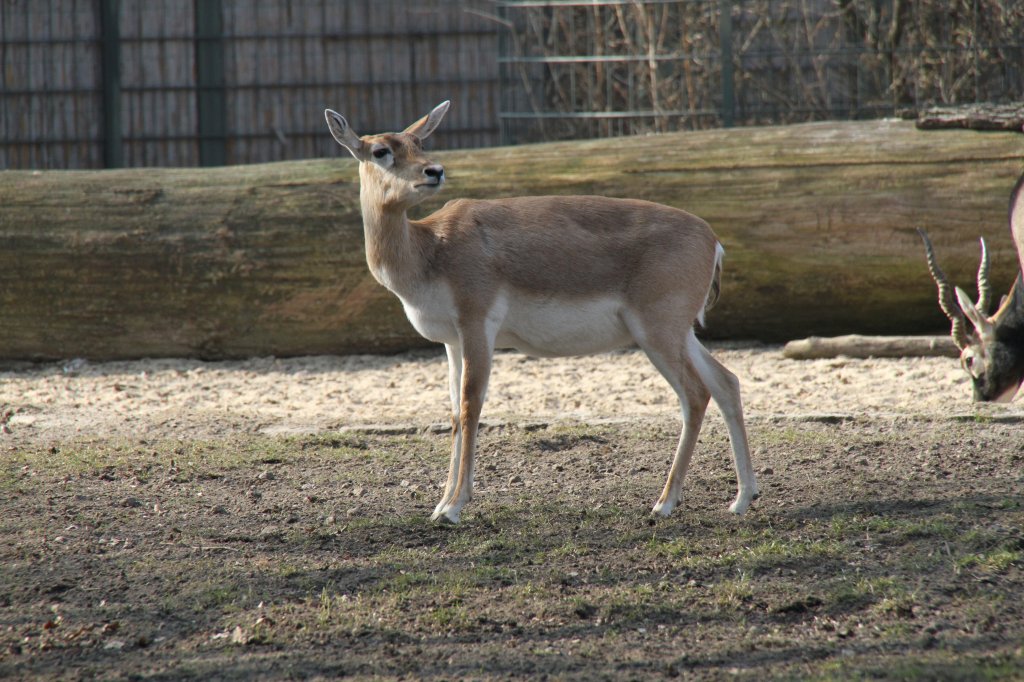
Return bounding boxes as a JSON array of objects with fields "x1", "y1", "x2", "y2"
[{"x1": 0, "y1": 345, "x2": 1024, "y2": 444}]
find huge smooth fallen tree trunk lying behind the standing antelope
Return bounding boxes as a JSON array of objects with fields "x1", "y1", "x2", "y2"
[{"x1": 0, "y1": 119, "x2": 1024, "y2": 359}]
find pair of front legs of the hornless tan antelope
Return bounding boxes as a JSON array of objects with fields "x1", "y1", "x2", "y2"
[{"x1": 430, "y1": 339, "x2": 494, "y2": 523}]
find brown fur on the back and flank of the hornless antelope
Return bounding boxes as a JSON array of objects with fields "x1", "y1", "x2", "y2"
[{"x1": 401, "y1": 197, "x2": 718, "y2": 315}]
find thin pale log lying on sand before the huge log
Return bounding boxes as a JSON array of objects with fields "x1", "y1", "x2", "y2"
[{"x1": 782, "y1": 334, "x2": 959, "y2": 359}]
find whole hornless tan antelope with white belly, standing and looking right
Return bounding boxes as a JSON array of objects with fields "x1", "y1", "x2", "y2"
[{"x1": 326, "y1": 101, "x2": 758, "y2": 523}]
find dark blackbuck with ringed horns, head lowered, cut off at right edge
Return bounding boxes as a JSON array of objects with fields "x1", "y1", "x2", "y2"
[{"x1": 918, "y1": 169, "x2": 1024, "y2": 402}]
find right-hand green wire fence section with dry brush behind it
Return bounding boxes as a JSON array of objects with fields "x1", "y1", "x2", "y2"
[{"x1": 500, "y1": 0, "x2": 1024, "y2": 141}]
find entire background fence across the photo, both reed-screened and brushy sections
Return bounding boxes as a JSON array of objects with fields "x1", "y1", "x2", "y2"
[{"x1": 0, "y1": 0, "x2": 1024, "y2": 168}]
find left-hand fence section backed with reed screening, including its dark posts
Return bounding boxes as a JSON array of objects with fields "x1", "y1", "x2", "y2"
[{"x1": 0, "y1": 0, "x2": 501, "y2": 168}]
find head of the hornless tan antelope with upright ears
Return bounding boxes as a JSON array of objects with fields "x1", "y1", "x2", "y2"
[{"x1": 325, "y1": 101, "x2": 449, "y2": 210}]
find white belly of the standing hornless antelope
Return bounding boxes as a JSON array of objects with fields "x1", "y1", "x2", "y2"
[{"x1": 488, "y1": 295, "x2": 633, "y2": 356}]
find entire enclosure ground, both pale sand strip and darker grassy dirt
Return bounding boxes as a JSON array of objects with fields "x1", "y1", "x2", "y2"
[{"x1": 0, "y1": 346, "x2": 1024, "y2": 680}]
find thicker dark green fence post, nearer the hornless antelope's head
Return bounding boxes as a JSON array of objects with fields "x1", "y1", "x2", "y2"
[{"x1": 195, "y1": 0, "x2": 227, "y2": 166}]
